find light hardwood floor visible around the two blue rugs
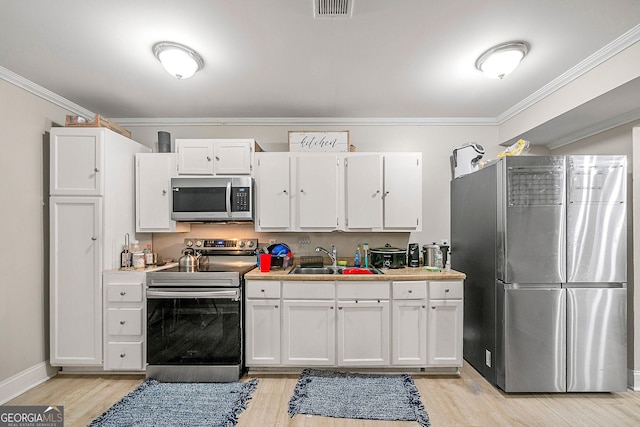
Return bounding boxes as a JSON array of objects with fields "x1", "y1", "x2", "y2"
[{"x1": 7, "y1": 364, "x2": 640, "y2": 427}]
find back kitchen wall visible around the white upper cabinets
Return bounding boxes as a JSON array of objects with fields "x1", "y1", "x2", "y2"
[{"x1": 127, "y1": 125, "x2": 504, "y2": 259}]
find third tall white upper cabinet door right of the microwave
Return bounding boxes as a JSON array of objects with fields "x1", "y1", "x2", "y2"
[{"x1": 344, "y1": 154, "x2": 383, "y2": 230}]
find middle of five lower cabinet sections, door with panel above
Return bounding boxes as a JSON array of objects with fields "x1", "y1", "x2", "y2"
[{"x1": 336, "y1": 281, "x2": 390, "y2": 366}]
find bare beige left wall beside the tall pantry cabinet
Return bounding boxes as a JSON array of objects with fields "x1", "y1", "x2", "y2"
[{"x1": 0, "y1": 80, "x2": 68, "y2": 394}]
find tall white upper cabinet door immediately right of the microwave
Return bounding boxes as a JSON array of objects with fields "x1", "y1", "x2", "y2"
[{"x1": 254, "y1": 153, "x2": 291, "y2": 231}]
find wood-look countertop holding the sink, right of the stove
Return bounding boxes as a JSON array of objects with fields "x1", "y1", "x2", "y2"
[{"x1": 244, "y1": 267, "x2": 467, "y2": 282}]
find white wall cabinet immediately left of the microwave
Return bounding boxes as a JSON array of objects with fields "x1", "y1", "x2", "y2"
[{"x1": 136, "y1": 153, "x2": 191, "y2": 233}]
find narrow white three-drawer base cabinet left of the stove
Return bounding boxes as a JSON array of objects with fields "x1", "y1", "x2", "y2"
[{"x1": 103, "y1": 271, "x2": 146, "y2": 371}]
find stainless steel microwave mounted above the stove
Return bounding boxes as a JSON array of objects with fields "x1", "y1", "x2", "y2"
[{"x1": 171, "y1": 176, "x2": 254, "y2": 222}]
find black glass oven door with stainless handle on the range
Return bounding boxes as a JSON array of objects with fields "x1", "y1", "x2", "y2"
[{"x1": 147, "y1": 288, "x2": 242, "y2": 365}]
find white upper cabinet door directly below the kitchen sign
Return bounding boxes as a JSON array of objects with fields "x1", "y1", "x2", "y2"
[{"x1": 295, "y1": 154, "x2": 339, "y2": 230}]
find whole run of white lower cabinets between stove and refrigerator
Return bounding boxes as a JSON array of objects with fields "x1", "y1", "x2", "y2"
[{"x1": 244, "y1": 280, "x2": 463, "y2": 368}]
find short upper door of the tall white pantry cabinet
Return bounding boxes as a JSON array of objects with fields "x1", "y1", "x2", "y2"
[{"x1": 50, "y1": 129, "x2": 104, "y2": 196}]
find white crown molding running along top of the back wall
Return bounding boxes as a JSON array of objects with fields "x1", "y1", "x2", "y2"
[{"x1": 111, "y1": 117, "x2": 497, "y2": 127}]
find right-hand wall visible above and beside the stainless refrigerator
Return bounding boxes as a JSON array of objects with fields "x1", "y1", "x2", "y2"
[{"x1": 551, "y1": 122, "x2": 640, "y2": 384}]
